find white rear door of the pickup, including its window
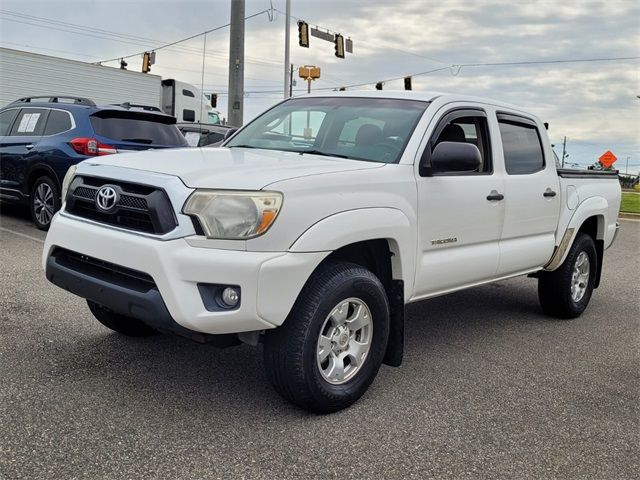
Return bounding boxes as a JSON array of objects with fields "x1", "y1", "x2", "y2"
[{"x1": 497, "y1": 112, "x2": 560, "y2": 276}]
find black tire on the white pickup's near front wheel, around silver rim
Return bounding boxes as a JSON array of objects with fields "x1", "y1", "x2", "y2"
[{"x1": 264, "y1": 262, "x2": 389, "y2": 413}]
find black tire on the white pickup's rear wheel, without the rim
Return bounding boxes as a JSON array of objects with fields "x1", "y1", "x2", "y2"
[{"x1": 538, "y1": 232, "x2": 600, "y2": 319}]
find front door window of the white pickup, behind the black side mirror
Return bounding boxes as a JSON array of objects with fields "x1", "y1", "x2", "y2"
[{"x1": 431, "y1": 115, "x2": 493, "y2": 174}]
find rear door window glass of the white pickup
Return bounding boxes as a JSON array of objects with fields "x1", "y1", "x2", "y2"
[{"x1": 498, "y1": 119, "x2": 544, "y2": 175}]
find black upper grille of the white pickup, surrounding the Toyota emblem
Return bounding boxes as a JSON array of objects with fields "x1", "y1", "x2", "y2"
[{"x1": 66, "y1": 176, "x2": 178, "y2": 235}]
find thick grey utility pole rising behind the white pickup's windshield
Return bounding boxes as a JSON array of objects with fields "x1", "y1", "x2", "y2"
[{"x1": 227, "y1": 0, "x2": 244, "y2": 127}]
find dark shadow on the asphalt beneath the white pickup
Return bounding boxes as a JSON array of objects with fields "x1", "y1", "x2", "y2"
[{"x1": 50, "y1": 279, "x2": 547, "y2": 417}]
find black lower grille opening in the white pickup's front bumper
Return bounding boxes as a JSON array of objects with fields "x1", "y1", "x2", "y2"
[{"x1": 51, "y1": 247, "x2": 157, "y2": 292}]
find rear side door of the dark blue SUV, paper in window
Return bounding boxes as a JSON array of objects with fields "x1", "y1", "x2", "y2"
[{"x1": 0, "y1": 107, "x2": 49, "y2": 194}]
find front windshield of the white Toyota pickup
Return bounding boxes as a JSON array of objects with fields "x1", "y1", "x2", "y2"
[{"x1": 224, "y1": 97, "x2": 428, "y2": 163}]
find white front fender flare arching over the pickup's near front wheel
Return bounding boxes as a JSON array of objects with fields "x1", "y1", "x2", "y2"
[{"x1": 289, "y1": 207, "x2": 416, "y2": 298}]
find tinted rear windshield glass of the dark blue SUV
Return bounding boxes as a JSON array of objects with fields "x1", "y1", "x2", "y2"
[{"x1": 90, "y1": 112, "x2": 186, "y2": 146}]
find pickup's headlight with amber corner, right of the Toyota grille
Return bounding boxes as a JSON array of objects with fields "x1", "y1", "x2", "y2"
[{"x1": 183, "y1": 190, "x2": 282, "y2": 240}]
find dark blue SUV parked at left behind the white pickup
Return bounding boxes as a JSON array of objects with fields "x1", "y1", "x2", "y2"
[{"x1": 0, "y1": 97, "x2": 188, "y2": 230}]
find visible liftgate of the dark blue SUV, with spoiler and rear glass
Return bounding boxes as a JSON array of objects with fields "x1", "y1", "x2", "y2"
[{"x1": 89, "y1": 110, "x2": 188, "y2": 152}]
